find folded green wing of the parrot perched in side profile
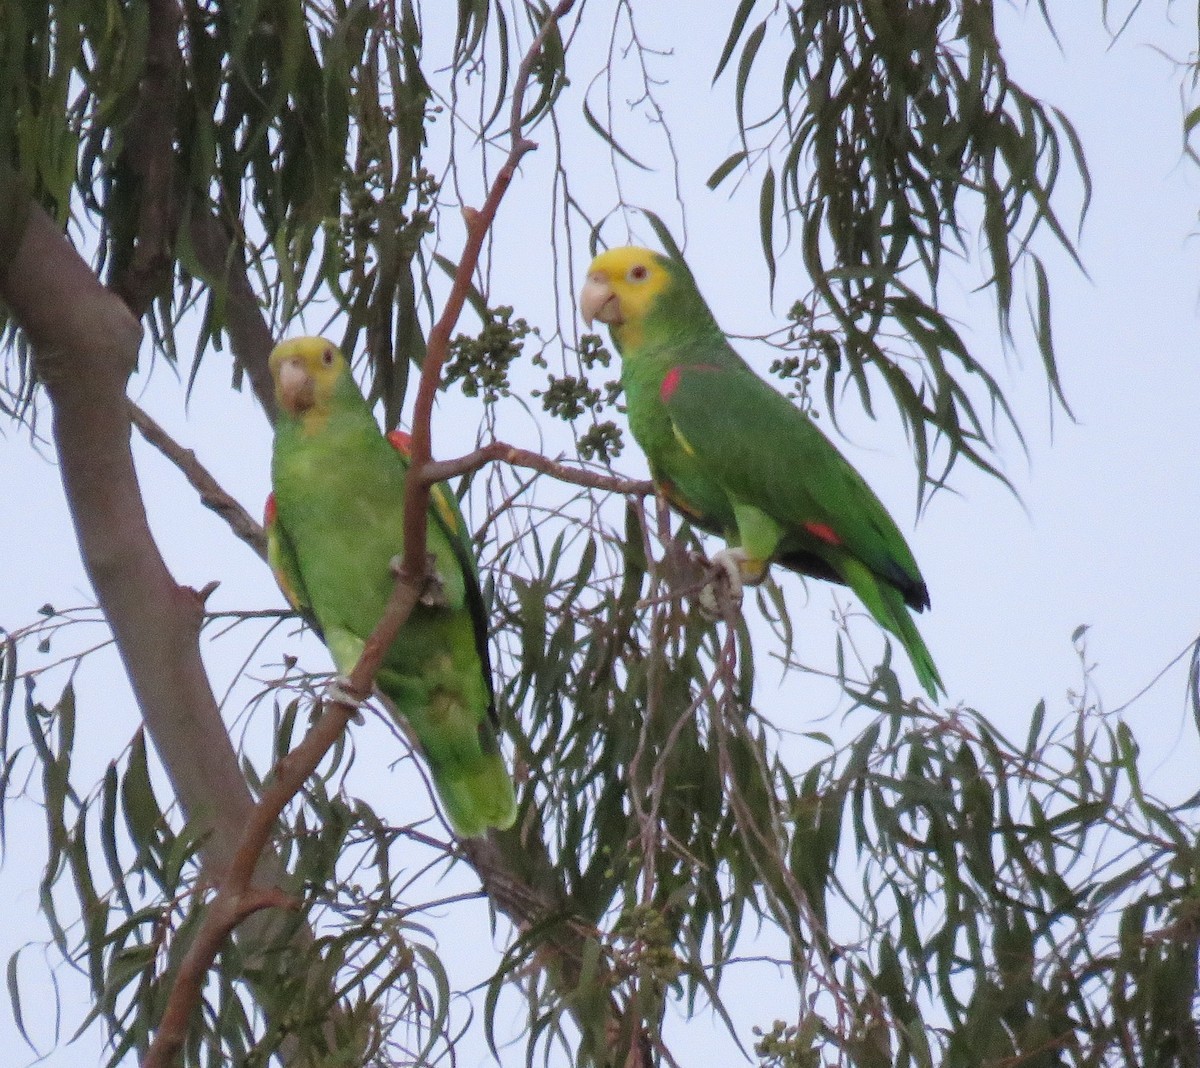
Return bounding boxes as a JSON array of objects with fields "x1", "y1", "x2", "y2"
[{"x1": 660, "y1": 362, "x2": 929, "y2": 610}]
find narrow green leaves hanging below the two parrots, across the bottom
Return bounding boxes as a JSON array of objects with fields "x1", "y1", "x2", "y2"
[{"x1": 7, "y1": 477, "x2": 1200, "y2": 1068}]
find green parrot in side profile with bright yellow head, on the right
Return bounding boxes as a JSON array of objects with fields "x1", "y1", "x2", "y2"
[{"x1": 580, "y1": 247, "x2": 944, "y2": 701}]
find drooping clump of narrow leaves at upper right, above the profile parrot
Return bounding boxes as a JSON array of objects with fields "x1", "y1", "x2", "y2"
[{"x1": 709, "y1": 0, "x2": 1090, "y2": 496}]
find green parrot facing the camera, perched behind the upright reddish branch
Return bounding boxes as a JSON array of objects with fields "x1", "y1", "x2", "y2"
[{"x1": 266, "y1": 337, "x2": 517, "y2": 836}]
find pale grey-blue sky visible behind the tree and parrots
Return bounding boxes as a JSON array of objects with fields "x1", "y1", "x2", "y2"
[{"x1": 0, "y1": 4, "x2": 1200, "y2": 1068}]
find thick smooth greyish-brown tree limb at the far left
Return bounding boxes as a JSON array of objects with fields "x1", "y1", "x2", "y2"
[{"x1": 0, "y1": 166, "x2": 324, "y2": 1056}]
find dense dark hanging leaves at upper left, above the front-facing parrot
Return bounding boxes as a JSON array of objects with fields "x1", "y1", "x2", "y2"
[{"x1": 0, "y1": 0, "x2": 437, "y2": 422}]
